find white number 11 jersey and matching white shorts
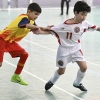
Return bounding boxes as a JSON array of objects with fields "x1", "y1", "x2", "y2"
[{"x1": 51, "y1": 18, "x2": 97, "y2": 69}]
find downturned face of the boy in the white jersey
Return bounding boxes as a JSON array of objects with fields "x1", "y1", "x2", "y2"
[{"x1": 75, "y1": 11, "x2": 88, "y2": 23}]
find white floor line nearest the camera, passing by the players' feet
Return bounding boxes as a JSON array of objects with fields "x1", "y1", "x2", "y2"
[{"x1": 4, "y1": 60, "x2": 84, "y2": 100}]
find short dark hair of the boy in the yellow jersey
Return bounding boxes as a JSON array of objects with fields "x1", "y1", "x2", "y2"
[{"x1": 27, "y1": 2, "x2": 42, "y2": 13}]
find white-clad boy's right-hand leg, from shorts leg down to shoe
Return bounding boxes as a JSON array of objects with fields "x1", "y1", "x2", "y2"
[{"x1": 73, "y1": 50, "x2": 87, "y2": 91}]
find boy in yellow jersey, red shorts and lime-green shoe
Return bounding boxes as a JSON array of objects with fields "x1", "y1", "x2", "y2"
[{"x1": 0, "y1": 3, "x2": 49, "y2": 85}]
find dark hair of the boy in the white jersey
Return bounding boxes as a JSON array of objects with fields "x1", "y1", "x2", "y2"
[{"x1": 74, "y1": 1, "x2": 91, "y2": 13}]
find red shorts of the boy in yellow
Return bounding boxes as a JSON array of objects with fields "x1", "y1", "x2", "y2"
[{"x1": 0, "y1": 37, "x2": 26, "y2": 62}]
